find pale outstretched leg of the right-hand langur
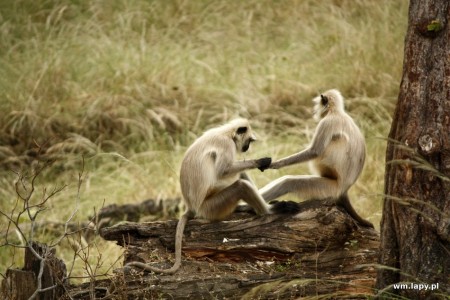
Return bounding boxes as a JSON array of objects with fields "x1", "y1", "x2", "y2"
[{"x1": 259, "y1": 175, "x2": 340, "y2": 201}]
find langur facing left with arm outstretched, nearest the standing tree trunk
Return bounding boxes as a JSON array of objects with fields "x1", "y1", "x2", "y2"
[{"x1": 259, "y1": 90, "x2": 373, "y2": 227}]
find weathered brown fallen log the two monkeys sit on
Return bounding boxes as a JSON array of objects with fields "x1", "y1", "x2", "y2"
[{"x1": 101, "y1": 201, "x2": 379, "y2": 299}]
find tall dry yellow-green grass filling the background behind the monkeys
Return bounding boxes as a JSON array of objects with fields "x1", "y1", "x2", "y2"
[{"x1": 0, "y1": 0, "x2": 408, "y2": 284}]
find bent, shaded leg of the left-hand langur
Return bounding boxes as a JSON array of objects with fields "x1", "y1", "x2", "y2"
[{"x1": 198, "y1": 179, "x2": 270, "y2": 220}]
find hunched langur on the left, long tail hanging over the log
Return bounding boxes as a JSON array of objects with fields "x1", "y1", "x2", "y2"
[{"x1": 127, "y1": 119, "x2": 282, "y2": 274}]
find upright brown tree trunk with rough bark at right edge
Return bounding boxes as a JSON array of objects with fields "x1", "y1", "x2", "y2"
[{"x1": 377, "y1": 0, "x2": 450, "y2": 299}]
